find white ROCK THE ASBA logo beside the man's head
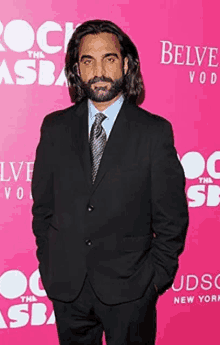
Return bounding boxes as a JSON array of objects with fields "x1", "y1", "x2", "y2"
[{"x1": 0, "y1": 19, "x2": 80, "y2": 86}]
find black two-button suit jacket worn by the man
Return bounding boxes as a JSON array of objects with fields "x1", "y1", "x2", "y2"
[{"x1": 32, "y1": 101, "x2": 188, "y2": 304}]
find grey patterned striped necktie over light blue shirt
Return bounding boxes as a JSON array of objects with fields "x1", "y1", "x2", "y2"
[{"x1": 89, "y1": 113, "x2": 107, "y2": 183}]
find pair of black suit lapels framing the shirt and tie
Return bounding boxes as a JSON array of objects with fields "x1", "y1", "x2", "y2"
[{"x1": 72, "y1": 100, "x2": 130, "y2": 193}]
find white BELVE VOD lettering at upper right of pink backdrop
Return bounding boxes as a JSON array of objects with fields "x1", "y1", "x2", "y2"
[{"x1": 160, "y1": 41, "x2": 220, "y2": 85}]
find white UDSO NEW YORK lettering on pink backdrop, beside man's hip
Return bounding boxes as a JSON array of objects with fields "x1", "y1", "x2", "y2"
[{"x1": 172, "y1": 273, "x2": 220, "y2": 304}]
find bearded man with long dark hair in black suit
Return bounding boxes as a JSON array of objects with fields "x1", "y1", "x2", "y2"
[{"x1": 32, "y1": 20, "x2": 188, "y2": 345}]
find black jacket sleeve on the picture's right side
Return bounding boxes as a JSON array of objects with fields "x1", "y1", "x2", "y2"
[{"x1": 150, "y1": 121, "x2": 188, "y2": 294}]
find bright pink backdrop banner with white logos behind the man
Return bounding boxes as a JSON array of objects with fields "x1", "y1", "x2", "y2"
[{"x1": 0, "y1": 0, "x2": 220, "y2": 345}]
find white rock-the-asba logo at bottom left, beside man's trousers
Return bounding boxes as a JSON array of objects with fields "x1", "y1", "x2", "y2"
[{"x1": 0, "y1": 270, "x2": 55, "y2": 329}]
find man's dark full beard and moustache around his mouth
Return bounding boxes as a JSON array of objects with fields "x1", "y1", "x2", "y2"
[{"x1": 82, "y1": 76, "x2": 124, "y2": 102}]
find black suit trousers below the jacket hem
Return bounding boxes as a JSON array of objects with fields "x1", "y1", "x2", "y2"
[{"x1": 52, "y1": 276, "x2": 158, "y2": 345}]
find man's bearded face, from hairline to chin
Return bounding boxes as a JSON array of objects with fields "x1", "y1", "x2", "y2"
[{"x1": 78, "y1": 32, "x2": 128, "y2": 102}]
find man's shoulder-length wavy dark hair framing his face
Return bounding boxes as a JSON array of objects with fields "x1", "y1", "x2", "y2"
[{"x1": 65, "y1": 19, "x2": 144, "y2": 104}]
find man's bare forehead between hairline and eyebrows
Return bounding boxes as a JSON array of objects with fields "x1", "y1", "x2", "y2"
[{"x1": 79, "y1": 32, "x2": 120, "y2": 55}]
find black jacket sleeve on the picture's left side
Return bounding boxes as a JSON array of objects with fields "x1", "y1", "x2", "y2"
[{"x1": 31, "y1": 117, "x2": 54, "y2": 260}]
